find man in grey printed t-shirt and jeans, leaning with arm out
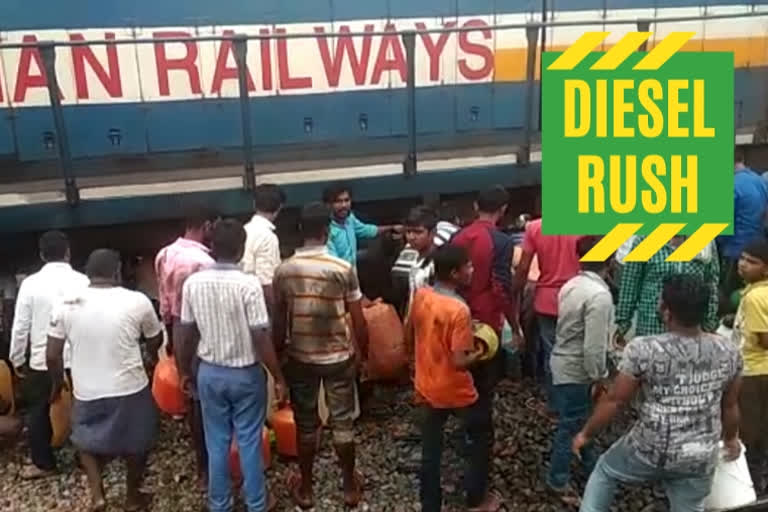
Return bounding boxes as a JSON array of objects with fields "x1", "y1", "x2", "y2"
[{"x1": 573, "y1": 275, "x2": 743, "y2": 512}]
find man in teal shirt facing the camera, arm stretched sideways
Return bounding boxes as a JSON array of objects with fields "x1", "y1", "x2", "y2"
[{"x1": 323, "y1": 183, "x2": 403, "y2": 267}]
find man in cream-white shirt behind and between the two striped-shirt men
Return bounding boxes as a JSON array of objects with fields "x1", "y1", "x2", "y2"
[{"x1": 241, "y1": 183, "x2": 285, "y2": 311}]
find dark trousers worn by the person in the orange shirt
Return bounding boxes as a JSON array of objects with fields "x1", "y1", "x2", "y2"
[{"x1": 420, "y1": 395, "x2": 491, "y2": 512}]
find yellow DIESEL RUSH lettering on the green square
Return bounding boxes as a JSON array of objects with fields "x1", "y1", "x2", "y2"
[{"x1": 564, "y1": 78, "x2": 715, "y2": 213}]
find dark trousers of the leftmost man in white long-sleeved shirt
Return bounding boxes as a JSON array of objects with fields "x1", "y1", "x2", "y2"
[{"x1": 23, "y1": 370, "x2": 56, "y2": 470}]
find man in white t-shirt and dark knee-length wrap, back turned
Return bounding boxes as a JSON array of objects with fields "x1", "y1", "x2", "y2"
[{"x1": 47, "y1": 249, "x2": 163, "y2": 510}]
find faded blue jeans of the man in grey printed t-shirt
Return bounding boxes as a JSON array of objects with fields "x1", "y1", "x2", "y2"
[{"x1": 580, "y1": 438, "x2": 714, "y2": 512}]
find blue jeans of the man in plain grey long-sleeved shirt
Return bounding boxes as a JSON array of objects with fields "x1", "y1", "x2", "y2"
[{"x1": 547, "y1": 384, "x2": 597, "y2": 490}]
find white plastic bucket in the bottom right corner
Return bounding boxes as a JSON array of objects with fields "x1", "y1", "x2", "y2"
[{"x1": 704, "y1": 443, "x2": 757, "y2": 511}]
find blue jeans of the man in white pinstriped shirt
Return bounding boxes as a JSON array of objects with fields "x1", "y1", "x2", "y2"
[{"x1": 197, "y1": 361, "x2": 267, "y2": 512}]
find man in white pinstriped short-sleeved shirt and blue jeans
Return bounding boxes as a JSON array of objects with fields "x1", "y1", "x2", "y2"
[{"x1": 176, "y1": 220, "x2": 285, "y2": 512}]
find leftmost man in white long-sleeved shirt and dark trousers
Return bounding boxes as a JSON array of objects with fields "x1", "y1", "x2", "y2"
[{"x1": 8, "y1": 231, "x2": 88, "y2": 479}]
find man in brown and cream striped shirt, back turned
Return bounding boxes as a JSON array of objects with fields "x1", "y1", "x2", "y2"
[{"x1": 272, "y1": 203, "x2": 368, "y2": 508}]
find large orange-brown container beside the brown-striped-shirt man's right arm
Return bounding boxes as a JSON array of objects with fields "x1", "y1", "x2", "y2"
[{"x1": 363, "y1": 303, "x2": 408, "y2": 380}]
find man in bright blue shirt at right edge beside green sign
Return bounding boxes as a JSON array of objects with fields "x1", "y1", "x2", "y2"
[{"x1": 718, "y1": 148, "x2": 768, "y2": 295}]
